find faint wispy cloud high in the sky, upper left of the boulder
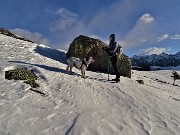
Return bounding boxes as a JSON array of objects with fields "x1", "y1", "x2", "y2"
[{"x1": 50, "y1": 8, "x2": 79, "y2": 31}]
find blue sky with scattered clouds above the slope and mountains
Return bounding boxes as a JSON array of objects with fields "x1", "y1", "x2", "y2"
[{"x1": 0, "y1": 0, "x2": 180, "y2": 56}]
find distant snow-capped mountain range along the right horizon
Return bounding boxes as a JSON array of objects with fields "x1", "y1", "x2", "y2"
[{"x1": 131, "y1": 52, "x2": 180, "y2": 67}]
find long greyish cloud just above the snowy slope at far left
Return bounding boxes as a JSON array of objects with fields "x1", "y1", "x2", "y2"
[{"x1": 10, "y1": 28, "x2": 49, "y2": 44}]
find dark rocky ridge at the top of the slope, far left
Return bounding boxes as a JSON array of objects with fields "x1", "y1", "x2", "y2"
[{"x1": 0, "y1": 28, "x2": 34, "y2": 43}]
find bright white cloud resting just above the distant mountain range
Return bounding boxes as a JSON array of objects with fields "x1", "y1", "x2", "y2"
[{"x1": 139, "y1": 47, "x2": 170, "y2": 56}]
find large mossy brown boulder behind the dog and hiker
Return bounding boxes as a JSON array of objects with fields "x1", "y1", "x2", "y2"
[{"x1": 67, "y1": 35, "x2": 131, "y2": 78}]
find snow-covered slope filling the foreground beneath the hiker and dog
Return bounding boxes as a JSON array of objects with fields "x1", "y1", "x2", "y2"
[{"x1": 0, "y1": 35, "x2": 180, "y2": 135}]
